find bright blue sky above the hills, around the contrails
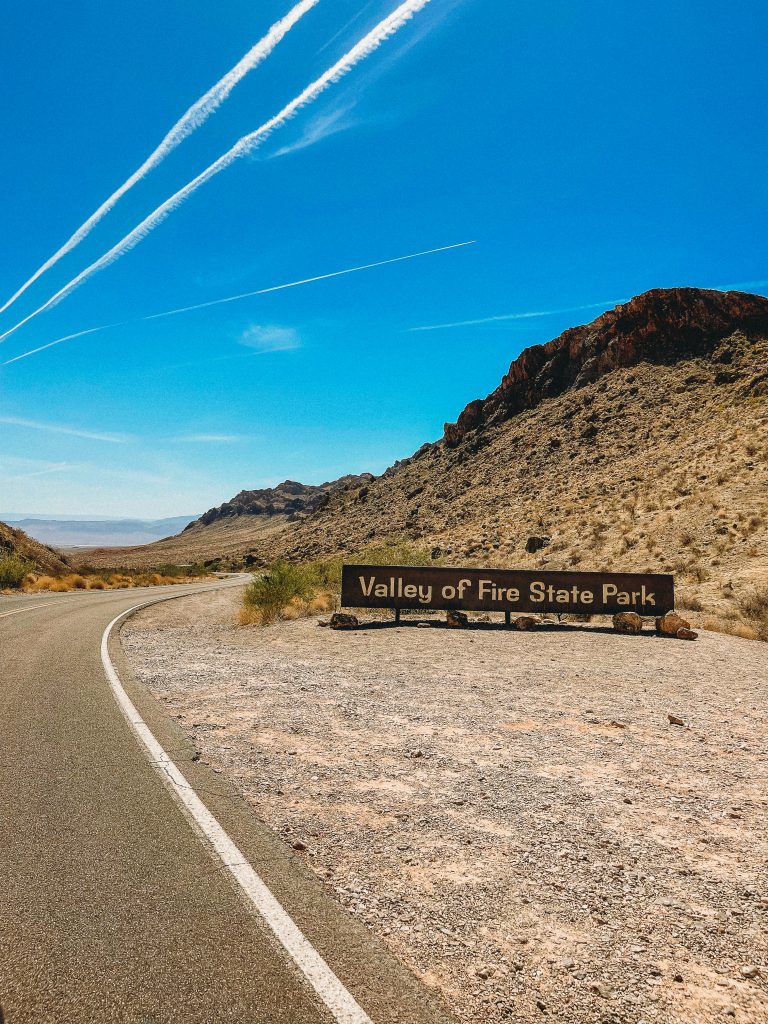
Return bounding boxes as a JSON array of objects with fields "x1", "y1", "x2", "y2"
[{"x1": 0, "y1": 0, "x2": 768, "y2": 516}]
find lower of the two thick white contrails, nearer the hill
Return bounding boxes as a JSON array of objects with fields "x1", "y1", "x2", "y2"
[{"x1": 0, "y1": 0, "x2": 430, "y2": 342}]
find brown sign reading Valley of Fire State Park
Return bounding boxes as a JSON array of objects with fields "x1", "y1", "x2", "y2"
[{"x1": 341, "y1": 565, "x2": 675, "y2": 615}]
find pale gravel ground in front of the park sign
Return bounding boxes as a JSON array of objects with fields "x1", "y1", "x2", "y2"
[{"x1": 122, "y1": 592, "x2": 768, "y2": 1024}]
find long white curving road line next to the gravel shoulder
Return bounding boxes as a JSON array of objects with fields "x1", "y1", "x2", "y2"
[{"x1": 101, "y1": 602, "x2": 373, "y2": 1024}]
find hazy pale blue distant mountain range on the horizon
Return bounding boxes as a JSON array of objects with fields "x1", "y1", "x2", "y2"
[{"x1": 7, "y1": 515, "x2": 195, "y2": 548}]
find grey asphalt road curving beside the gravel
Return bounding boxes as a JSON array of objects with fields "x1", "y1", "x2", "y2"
[{"x1": 0, "y1": 581, "x2": 450, "y2": 1024}]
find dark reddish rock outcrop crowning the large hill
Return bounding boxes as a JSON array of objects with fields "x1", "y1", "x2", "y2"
[{"x1": 444, "y1": 288, "x2": 768, "y2": 447}]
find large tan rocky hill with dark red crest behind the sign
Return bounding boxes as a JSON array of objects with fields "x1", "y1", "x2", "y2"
[{"x1": 78, "y1": 289, "x2": 768, "y2": 622}]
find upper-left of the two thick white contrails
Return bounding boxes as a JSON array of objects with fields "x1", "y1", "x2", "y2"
[{"x1": 0, "y1": 0, "x2": 319, "y2": 313}]
